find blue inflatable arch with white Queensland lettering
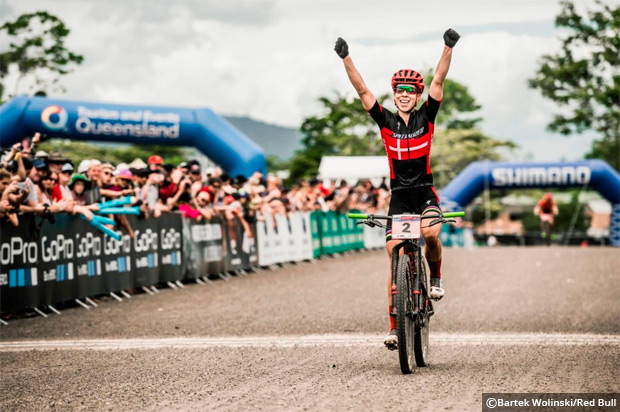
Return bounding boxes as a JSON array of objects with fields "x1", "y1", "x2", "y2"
[{"x1": 0, "y1": 97, "x2": 267, "y2": 177}]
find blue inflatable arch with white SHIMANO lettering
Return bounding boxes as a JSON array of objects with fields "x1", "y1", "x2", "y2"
[{"x1": 441, "y1": 160, "x2": 620, "y2": 246}]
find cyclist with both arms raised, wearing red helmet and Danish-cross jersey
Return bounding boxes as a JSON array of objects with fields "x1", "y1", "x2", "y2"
[{"x1": 334, "y1": 29, "x2": 460, "y2": 349}]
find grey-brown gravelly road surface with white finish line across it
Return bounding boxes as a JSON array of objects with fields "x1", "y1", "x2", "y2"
[{"x1": 0, "y1": 248, "x2": 620, "y2": 411}]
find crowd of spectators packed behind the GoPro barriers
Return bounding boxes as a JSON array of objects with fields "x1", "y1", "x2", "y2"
[{"x1": 0, "y1": 134, "x2": 389, "y2": 236}]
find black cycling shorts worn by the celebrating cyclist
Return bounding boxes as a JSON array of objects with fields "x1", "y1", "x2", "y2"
[{"x1": 385, "y1": 186, "x2": 441, "y2": 242}]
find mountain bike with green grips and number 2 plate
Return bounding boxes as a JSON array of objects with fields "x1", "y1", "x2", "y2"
[{"x1": 347, "y1": 212, "x2": 465, "y2": 374}]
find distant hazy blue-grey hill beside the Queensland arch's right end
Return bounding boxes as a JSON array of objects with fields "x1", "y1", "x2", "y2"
[{"x1": 224, "y1": 116, "x2": 303, "y2": 160}]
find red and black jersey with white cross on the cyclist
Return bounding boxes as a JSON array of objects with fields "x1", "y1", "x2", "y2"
[{"x1": 368, "y1": 96, "x2": 441, "y2": 190}]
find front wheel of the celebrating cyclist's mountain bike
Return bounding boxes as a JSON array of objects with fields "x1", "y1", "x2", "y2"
[{"x1": 394, "y1": 255, "x2": 414, "y2": 374}]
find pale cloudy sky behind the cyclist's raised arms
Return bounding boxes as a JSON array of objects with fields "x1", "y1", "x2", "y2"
[{"x1": 0, "y1": 0, "x2": 592, "y2": 161}]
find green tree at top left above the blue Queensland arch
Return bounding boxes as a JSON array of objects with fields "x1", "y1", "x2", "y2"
[{"x1": 0, "y1": 11, "x2": 84, "y2": 102}]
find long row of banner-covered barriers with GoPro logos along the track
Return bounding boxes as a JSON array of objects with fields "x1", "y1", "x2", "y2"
[{"x1": 0, "y1": 212, "x2": 385, "y2": 311}]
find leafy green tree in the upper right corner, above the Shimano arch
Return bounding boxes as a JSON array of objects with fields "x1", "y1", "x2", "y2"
[{"x1": 529, "y1": 0, "x2": 620, "y2": 170}]
